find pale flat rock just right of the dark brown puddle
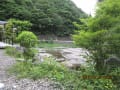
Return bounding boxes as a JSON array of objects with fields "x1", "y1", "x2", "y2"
[{"x1": 61, "y1": 48, "x2": 89, "y2": 68}]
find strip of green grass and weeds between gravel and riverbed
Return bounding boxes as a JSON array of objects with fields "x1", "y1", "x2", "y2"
[{"x1": 9, "y1": 58, "x2": 116, "y2": 90}]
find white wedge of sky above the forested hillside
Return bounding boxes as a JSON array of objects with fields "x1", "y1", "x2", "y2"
[{"x1": 72, "y1": 0, "x2": 97, "y2": 16}]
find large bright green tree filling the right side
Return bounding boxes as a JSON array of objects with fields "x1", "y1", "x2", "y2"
[{"x1": 73, "y1": 0, "x2": 120, "y2": 74}]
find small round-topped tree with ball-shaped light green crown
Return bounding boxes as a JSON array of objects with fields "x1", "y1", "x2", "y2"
[{"x1": 17, "y1": 31, "x2": 38, "y2": 62}]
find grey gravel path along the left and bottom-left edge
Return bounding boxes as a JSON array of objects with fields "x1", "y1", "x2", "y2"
[{"x1": 0, "y1": 49, "x2": 61, "y2": 90}]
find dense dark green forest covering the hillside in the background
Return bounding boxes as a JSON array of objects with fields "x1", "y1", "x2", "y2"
[{"x1": 0, "y1": 0, "x2": 87, "y2": 36}]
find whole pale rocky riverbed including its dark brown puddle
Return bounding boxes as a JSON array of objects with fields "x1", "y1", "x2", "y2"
[{"x1": 39, "y1": 48, "x2": 89, "y2": 68}]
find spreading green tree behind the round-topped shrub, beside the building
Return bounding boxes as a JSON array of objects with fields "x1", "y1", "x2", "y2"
[{"x1": 5, "y1": 19, "x2": 32, "y2": 42}]
